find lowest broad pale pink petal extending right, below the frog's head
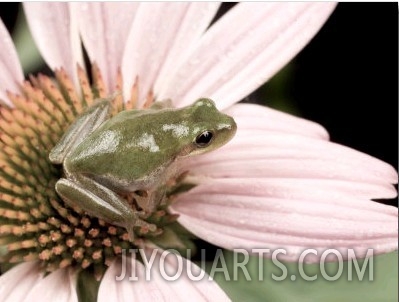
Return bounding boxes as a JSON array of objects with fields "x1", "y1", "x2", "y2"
[{"x1": 172, "y1": 178, "x2": 398, "y2": 262}]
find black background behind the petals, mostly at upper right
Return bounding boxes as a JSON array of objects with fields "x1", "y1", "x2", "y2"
[{"x1": 0, "y1": 3, "x2": 398, "y2": 168}]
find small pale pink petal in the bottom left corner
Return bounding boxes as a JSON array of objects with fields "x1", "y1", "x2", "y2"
[{"x1": 0, "y1": 262, "x2": 43, "y2": 302}]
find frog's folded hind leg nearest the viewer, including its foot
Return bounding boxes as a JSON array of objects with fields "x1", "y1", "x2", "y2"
[{"x1": 55, "y1": 175, "x2": 156, "y2": 241}]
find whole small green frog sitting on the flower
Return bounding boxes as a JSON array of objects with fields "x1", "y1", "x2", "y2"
[{"x1": 49, "y1": 98, "x2": 237, "y2": 242}]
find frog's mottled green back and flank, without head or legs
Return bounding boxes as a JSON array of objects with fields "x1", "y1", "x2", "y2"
[{"x1": 66, "y1": 110, "x2": 180, "y2": 189}]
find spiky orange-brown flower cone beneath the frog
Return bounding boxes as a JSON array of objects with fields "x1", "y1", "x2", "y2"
[{"x1": 0, "y1": 66, "x2": 197, "y2": 279}]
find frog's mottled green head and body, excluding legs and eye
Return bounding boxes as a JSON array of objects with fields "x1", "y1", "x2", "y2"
[{"x1": 64, "y1": 100, "x2": 235, "y2": 191}]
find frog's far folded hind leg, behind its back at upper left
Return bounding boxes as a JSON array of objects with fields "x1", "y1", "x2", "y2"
[{"x1": 49, "y1": 99, "x2": 112, "y2": 164}]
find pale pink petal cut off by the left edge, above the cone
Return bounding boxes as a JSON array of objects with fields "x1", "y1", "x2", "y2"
[{"x1": 0, "y1": 20, "x2": 24, "y2": 105}]
